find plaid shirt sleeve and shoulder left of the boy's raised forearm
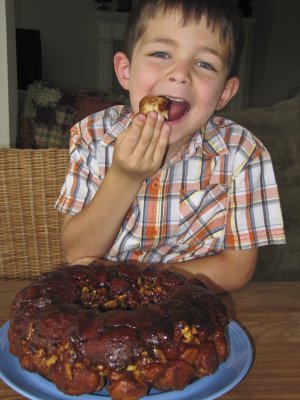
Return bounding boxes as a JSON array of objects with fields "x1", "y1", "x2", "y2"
[{"x1": 55, "y1": 105, "x2": 132, "y2": 214}]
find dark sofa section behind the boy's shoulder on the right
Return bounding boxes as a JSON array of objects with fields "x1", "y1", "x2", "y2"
[{"x1": 223, "y1": 96, "x2": 300, "y2": 280}]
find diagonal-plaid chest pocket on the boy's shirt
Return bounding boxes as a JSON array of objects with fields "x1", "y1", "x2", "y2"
[{"x1": 178, "y1": 184, "x2": 229, "y2": 250}]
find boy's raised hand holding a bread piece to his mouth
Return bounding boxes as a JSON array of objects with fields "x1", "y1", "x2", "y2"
[{"x1": 111, "y1": 112, "x2": 171, "y2": 180}]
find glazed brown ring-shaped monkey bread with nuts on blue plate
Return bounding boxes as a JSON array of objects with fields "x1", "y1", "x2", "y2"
[{"x1": 9, "y1": 261, "x2": 229, "y2": 400}]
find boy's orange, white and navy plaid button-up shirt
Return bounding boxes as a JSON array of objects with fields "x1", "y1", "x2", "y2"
[{"x1": 56, "y1": 106, "x2": 285, "y2": 262}]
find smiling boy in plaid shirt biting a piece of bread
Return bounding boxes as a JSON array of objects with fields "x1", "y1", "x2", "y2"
[{"x1": 56, "y1": 0, "x2": 284, "y2": 292}]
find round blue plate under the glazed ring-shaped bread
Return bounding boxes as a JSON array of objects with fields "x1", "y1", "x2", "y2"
[{"x1": 0, "y1": 321, "x2": 253, "y2": 400}]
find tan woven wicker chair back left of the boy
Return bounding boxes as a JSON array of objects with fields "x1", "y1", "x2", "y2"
[{"x1": 0, "y1": 149, "x2": 68, "y2": 278}]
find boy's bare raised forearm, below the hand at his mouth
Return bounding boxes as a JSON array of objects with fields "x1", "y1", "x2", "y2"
[{"x1": 62, "y1": 169, "x2": 142, "y2": 263}]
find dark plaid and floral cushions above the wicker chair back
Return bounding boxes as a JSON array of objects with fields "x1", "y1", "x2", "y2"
[{"x1": 18, "y1": 81, "x2": 127, "y2": 149}]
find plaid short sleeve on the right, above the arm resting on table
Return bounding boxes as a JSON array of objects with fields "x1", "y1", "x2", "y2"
[{"x1": 224, "y1": 147, "x2": 285, "y2": 250}]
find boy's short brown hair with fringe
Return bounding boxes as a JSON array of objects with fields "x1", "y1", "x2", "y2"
[{"x1": 124, "y1": 0, "x2": 244, "y2": 78}]
